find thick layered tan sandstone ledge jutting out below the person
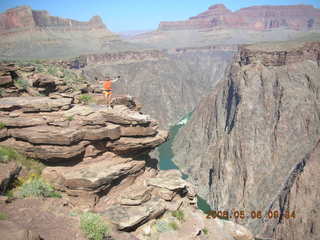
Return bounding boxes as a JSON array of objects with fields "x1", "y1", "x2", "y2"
[{"x1": 0, "y1": 97, "x2": 167, "y2": 162}]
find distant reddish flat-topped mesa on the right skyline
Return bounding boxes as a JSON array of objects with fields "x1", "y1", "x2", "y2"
[{"x1": 159, "y1": 4, "x2": 320, "y2": 31}]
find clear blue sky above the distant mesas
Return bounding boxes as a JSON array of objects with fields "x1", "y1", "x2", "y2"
[{"x1": 0, "y1": 0, "x2": 320, "y2": 32}]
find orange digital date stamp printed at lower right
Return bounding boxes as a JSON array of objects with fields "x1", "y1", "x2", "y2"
[{"x1": 207, "y1": 210, "x2": 296, "y2": 219}]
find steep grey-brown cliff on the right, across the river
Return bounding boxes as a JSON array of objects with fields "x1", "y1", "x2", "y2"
[{"x1": 174, "y1": 42, "x2": 320, "y2": 239}]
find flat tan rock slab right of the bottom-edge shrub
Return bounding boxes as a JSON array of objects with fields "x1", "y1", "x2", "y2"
[{"x1": 102, "y1": 199, "x2": 165, "y2": 231}]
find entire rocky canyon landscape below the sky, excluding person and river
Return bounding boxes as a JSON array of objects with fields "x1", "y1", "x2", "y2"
[{"x1": 0, "y1": 4, "x2": 320, "y2": 240}]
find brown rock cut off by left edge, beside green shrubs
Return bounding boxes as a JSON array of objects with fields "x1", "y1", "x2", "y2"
[{"x1": 0, "y1": 161, "x2": 21, "y2": 195}]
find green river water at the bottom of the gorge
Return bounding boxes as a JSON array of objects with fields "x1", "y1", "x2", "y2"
[{"x1": 158, "y1": 113, "x2": 211, "y2": 213}]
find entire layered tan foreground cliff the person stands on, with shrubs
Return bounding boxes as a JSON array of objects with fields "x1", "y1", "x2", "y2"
[{"x1": 0, "y1": 61, "x2": 253, "y2": 240}]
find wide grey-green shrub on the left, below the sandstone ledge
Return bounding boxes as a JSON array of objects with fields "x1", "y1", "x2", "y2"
[{"x1": 15, "y1": 177, "x2": 61, "y2": 198}]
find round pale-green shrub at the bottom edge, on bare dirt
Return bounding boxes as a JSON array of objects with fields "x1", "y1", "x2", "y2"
[{"x1": 80, "y1": 212, "x2": 109, "y2": 240}]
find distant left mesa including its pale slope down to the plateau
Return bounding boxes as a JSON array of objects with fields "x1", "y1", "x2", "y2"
[{"x1": 0, "y1": 6, "x2": 134, "y2": 60}]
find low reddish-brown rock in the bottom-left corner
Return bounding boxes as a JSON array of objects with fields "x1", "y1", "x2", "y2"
[{"x1": 0, "y1": 221, "x2": 41, "y2": 240}]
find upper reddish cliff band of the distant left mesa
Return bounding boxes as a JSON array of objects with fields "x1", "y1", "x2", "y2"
[{"x1": 0, "y1": 6, "x2": 108, "y2": 34}]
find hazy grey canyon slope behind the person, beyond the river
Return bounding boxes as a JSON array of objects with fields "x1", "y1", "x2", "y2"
[{"x1": 84, "y1": 47, "x2": 233, "y2": 127}]
